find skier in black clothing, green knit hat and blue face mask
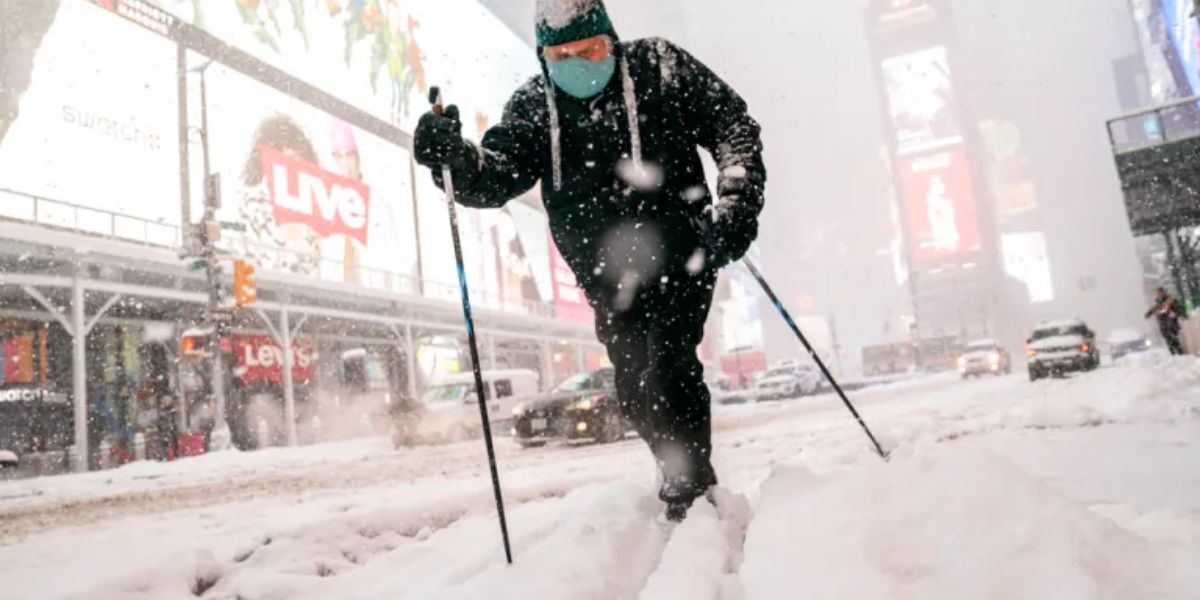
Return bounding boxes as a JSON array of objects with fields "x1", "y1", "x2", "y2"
[{"x1": 414, "y1": 0, "x2": 767, "y2": 521}]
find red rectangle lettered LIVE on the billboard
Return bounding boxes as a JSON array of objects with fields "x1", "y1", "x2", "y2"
[{"x1": 258, "y1": 146, "x2": 371, "y2": 245}]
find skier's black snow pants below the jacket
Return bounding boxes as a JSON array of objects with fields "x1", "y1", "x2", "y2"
[{"x1": 589, "y1": 272, "x2": 716, "y2": 502}]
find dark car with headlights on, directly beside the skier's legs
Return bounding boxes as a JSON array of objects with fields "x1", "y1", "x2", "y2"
[{"x1": 512, "y1": 368, "x2": 629, "y2": 448}]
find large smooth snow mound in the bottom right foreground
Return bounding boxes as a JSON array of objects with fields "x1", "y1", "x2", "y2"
[{"x1": 740, "y1": 446, "x2": 1200, "y2": 600}]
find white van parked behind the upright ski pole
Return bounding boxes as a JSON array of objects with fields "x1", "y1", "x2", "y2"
[{"x1": 418, "y1": 370, "x2": 539, "y2": 439}]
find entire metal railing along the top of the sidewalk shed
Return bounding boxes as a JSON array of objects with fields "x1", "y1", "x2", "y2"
[{"x1": 0, "y1": 188, "x2": 556, "y2": 318}]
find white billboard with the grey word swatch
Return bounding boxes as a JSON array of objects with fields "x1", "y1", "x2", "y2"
[{"x1": 0, "y1": 2, "x2": 180, "y2": 234}]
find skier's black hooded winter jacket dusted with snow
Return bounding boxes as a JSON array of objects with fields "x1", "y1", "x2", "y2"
[{"x1": 446, "y1": 40, "x2": 767, "y2": 302}]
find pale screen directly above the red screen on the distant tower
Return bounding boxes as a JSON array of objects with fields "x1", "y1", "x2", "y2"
[{"x1": 883, "y1": 46, "x2": 962, "y2": 155}]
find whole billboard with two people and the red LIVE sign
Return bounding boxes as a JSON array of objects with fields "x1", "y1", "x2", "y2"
[{"x1": 206, "y1": 65, "x2": 416, "y2": 288}]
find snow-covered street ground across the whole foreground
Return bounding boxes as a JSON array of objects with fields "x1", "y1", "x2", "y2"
[{"x1": 0, "y1": 356, "x2": 1200, "y2": 600}]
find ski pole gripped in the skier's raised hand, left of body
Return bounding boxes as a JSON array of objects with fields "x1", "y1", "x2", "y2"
[{"x1": 430, "y1": 88, "x2": 512, "y2": 564}]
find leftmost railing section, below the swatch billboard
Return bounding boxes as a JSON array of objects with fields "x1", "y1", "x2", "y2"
[{"x1": 0, "y1": 188, "x2": 180, "y2": 248}]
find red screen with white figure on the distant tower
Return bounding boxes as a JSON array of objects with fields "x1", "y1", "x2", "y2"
[{"x1": 899, "y1": 146, "x2": 980, "y2": 260}]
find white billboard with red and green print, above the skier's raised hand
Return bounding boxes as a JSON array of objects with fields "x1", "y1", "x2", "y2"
[{"x1": 148, "y1": 0, "x2": 536, "y2": 131}]
